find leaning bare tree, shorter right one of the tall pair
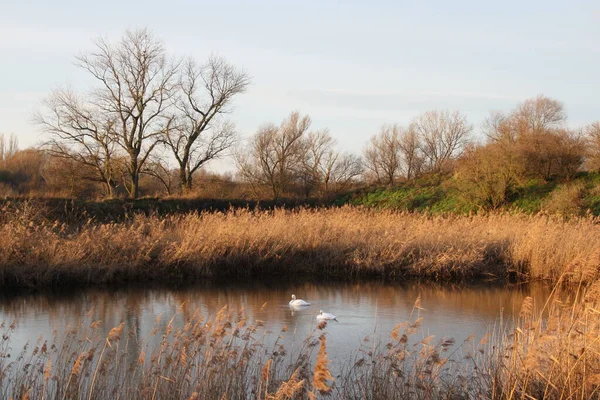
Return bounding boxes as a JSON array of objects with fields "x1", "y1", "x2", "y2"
[{"x1": 166, "y1": 56, "x2": 250, "y2": 191}]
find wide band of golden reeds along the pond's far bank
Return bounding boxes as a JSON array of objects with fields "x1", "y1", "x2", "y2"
[{"x1": 0, "y1": 207, "x2": 600, "y2": 288}]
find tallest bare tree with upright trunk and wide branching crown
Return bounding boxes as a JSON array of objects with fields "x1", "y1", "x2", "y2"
[{"x1": 77, "y1": 29, "x2": 178, "y2": 198}]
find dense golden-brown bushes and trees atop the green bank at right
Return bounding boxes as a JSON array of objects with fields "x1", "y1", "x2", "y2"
[{"x1": 455, "y1": 96, "x2": 594, "y2": 209}]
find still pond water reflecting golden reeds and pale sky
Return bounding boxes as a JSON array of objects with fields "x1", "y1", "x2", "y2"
[{"x1": 0, "y1": 281, "x2": 549, "y2": 363}]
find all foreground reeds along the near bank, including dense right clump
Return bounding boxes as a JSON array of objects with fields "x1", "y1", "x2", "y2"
[{"x1": 0, "y1": 284, "x2": 600, "y2": 400}]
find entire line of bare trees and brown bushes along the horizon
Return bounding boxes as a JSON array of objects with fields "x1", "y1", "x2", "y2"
[{"x1": 0, "y1": 29, "x2": 600, "y2": 208}]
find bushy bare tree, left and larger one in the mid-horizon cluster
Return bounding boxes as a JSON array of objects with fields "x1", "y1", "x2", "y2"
[{"x1": 236, "y1": 112, "x2": 311, "y2": 200}]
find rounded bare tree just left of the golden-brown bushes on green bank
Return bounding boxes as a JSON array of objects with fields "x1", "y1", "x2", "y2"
[{"x1": 410, "y1": 110, "x2": 473, "y2": 172}]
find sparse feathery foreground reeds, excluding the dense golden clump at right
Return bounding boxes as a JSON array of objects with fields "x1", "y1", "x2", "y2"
[{"x1": 0, "y1": 298, "x2": 496, "y2": 400}]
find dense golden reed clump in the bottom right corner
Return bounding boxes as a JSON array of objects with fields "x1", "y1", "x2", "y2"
[{"x1": 495, "y1": 282, "x2": 600, "y2": 399}]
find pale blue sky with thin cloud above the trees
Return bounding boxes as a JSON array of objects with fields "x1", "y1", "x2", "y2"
[{"x1": 0, "y1": 0, "x2": 600, "y2": 170}]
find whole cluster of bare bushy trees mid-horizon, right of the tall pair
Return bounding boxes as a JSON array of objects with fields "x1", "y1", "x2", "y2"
[{"x1": 236, "y1": 112, "x2": 362, "y2": 199}]
